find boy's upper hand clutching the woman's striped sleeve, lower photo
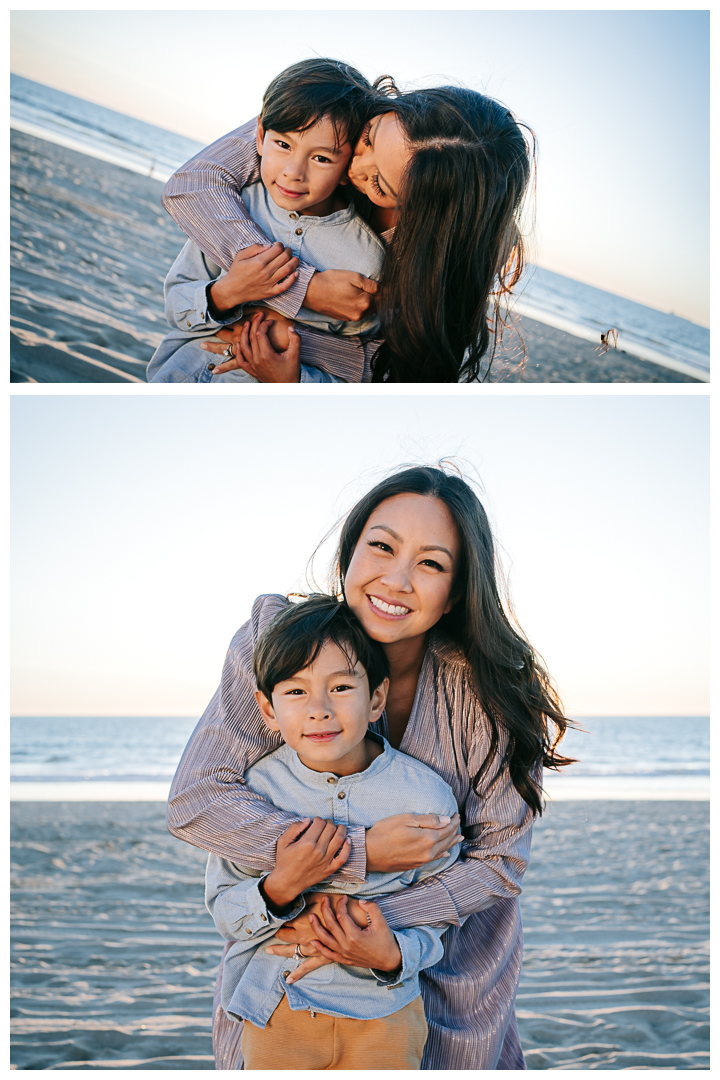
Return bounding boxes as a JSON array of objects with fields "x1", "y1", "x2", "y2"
[{"x1": 261, "y1": 818, "x2": 350, "y2": 913}]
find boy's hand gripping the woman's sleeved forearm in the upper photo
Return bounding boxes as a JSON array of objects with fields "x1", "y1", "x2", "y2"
[{"x1": 208, "y1": 243, "x2": 299, "y2": 319}]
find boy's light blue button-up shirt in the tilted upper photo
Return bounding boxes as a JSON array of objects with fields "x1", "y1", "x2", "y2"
[{"x1": 147, "y1": 183, "x2": 385, "y2": 382}]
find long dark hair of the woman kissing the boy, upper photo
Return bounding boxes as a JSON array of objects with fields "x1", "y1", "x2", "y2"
[{"x1": 372, "y1": 87, "x2": 534, "y2": 382}]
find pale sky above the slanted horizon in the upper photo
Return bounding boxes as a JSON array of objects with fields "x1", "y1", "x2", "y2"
[{"x1": 11, "y1": 5, "x2": 709, "y2": 325}]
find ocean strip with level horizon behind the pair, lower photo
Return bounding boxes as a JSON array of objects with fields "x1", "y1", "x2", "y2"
[{"x1": 11, "y1": 716, "x2": 710, "y2": 801}]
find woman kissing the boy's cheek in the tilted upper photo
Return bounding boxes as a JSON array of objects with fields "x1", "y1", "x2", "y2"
[{"x1": 163, "y1": 66, "x2": 531, "y2": 382}]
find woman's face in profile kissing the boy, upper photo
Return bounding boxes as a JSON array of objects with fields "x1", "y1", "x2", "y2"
[{"x1": 348, "y1": 112, "x2": 410, "y2": 208}]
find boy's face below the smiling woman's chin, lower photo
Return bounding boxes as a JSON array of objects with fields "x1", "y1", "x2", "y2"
[{"x1": 256, "y1": 642, "x2": 388, "y2": 777}]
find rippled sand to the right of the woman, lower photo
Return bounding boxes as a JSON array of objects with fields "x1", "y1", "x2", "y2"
[{"x1": 517, "y1": 802, "x2": 709, "y2": 1069}]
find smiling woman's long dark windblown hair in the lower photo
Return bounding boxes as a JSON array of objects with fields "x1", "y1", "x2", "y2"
[{"x1": 332, "y1": 467, "x2": 573, "y2": 814}]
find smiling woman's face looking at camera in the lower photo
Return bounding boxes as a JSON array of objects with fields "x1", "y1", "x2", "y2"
[{"x1": 344, "y1": 495, "x2": 460, "y2": 645}]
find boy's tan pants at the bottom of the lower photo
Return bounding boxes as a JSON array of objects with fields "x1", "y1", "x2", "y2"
[{"x1": 243, "y1": 990, "x2": 427, "y2": 1069}]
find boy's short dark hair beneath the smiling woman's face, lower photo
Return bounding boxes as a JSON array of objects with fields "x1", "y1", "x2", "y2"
[{"x1": 253, "y1": 593, "x2": 390, "y2": 699}]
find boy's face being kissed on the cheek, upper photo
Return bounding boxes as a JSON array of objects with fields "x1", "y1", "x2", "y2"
[{"x1": 258, "y1": 118, "x2": 352, "y2": 217}]
